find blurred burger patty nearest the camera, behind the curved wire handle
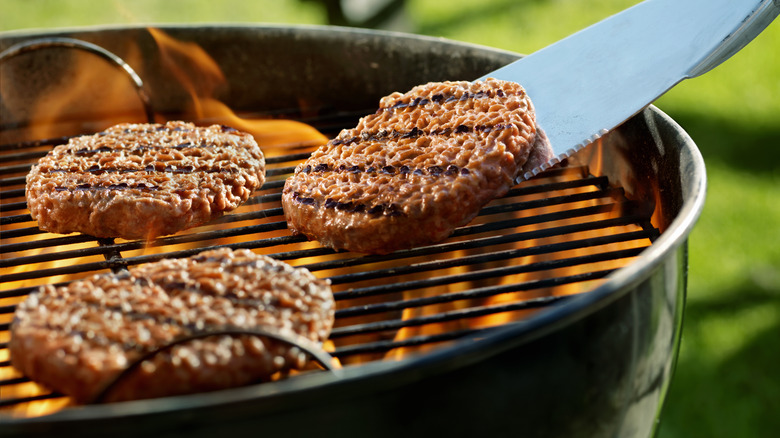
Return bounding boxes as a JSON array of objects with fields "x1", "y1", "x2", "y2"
[{"x1": 9, "y1": 249, "x2": 335, "y2": 403}]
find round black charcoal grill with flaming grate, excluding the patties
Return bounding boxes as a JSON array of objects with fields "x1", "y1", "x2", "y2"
[{"x1": 0, "y1": 26, "x2": 705, "y2": 437}]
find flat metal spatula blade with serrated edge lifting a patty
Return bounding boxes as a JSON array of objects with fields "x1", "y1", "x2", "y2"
[{"x1": 484, "y1": 0, "x2": 780, "y2": 177}]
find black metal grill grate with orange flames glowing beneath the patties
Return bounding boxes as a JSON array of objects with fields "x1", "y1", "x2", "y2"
[{"x1": 0, "y1": 125, "x2": 659, "y2": 410}]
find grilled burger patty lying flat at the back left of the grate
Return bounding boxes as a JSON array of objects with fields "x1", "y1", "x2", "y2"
[{"x1": 26, "y1": 122, "x2": 265, "y2": 239}]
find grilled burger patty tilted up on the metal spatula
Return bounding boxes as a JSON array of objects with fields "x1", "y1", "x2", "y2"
[{"x1": 282, "y1": 79, "x2": 552, "y2": 253}]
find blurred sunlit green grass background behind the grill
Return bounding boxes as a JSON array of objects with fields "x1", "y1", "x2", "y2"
[{"x1": 0, "y1": 0, "x2": 780, "y2": 438}]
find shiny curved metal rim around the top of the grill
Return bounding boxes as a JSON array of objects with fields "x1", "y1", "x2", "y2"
[{"x1": 0, "y1": 24, "x2": 706, "y2": 432}]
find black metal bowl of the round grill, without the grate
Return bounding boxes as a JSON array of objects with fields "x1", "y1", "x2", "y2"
[{"x1": 0, "y1": 26, "x2": 705, "y2": 438}]
